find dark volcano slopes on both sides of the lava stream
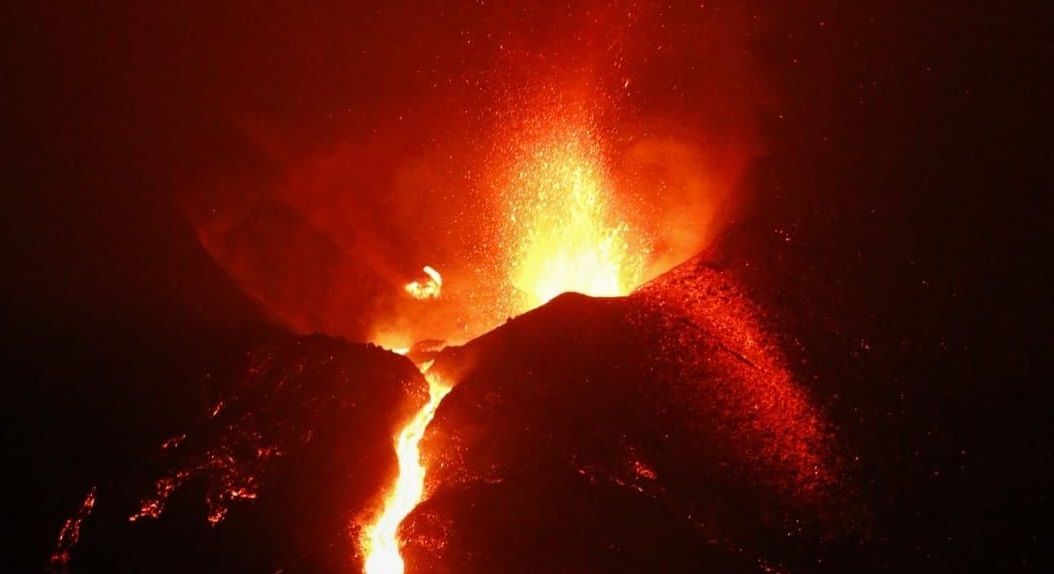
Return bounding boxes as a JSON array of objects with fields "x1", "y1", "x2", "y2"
[{"x1": 53, "y1": 255, "x2": 847, "y2": 574}]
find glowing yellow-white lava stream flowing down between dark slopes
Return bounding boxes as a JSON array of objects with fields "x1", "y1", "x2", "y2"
[{"x1": 364, "y1": 372, "x2": 452, "y2": 574}]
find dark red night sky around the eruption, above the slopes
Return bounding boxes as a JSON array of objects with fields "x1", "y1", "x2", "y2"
[{"x1": 0, "y1": 2, "x2": 1054, "y2": 572}]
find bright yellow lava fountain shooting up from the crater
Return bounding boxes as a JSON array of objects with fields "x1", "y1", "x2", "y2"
[{"x1": 506, "y1": 121, "x2": 646, "y2": 313}]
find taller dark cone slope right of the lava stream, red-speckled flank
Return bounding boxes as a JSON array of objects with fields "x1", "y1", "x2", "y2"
[{"x1": 404, "y1": 256, "x2": 847, "y2": 573}]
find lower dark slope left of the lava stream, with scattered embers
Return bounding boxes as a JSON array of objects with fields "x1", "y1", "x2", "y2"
[{"x1": 53, "y1": 335, "x2": 428, "y2": 573}]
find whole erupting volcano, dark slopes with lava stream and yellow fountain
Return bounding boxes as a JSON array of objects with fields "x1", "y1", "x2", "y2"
[{"x1": 43, "y1": 73, "x2": 844, "y2": 574}]
